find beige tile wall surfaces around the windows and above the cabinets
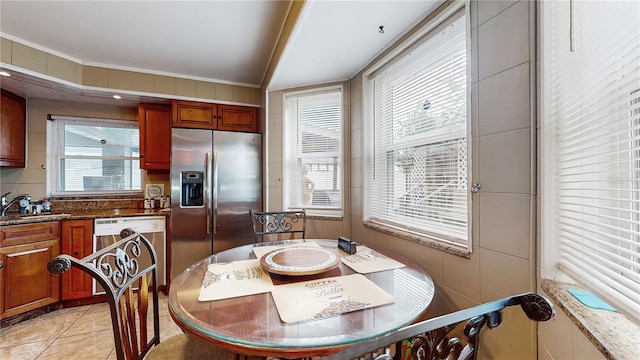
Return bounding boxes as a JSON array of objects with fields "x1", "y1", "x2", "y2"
[{"x1": 0, "y1": 0, "x2": 602, "y2": 359}]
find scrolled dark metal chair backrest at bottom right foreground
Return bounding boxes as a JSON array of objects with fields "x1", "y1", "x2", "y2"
[{"x1": 325, "y1": 293, "x2": 555, "y2": 360}]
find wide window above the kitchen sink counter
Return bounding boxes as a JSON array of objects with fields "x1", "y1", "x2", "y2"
[{"x1": 50, "y1": 115, "x2": 142, "y2": 195}]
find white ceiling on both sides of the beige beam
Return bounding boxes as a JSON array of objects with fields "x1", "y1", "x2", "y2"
[{"x1": 0, "y1": 0, "x2": 442, "y2": 101}]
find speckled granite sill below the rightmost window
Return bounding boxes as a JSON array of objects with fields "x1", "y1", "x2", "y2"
[{"x1": 541, "y1": 279, "x2": 640, "y2": 360}]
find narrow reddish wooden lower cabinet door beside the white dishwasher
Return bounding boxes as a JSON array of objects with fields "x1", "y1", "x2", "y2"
[{"x1": 60, "y1": 220, "x2": 93, "y2": 300}]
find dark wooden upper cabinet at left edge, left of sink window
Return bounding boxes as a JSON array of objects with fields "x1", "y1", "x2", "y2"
[{"x1": 0, "y1": 89, "x2": 27, "y2": 167}]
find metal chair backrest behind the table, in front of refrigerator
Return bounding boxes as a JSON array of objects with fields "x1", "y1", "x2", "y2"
[{"x1": 249, "y1": 209, "x2": 307, "y2": 242}]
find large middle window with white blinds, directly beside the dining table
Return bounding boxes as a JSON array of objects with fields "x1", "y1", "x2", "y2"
[{"x1": 363, "y1": 6, "x2": 471, "y2": 251}]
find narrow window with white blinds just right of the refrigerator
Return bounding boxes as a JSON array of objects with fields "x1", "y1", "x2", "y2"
[{"x1": 283, "y1": 86, "x2": 343, "y2": 216}]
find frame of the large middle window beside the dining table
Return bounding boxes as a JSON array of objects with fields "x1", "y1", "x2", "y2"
[{"x1": 362, "y1": 2, "x2": 473, "y2": 253}]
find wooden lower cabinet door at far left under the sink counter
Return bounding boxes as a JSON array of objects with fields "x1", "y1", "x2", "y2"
[{"x1": 0, "y1": 239, "x2": 60, "y2": 319}]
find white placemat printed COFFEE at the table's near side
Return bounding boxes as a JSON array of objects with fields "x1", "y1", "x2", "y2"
[{"x1": 271, "y1": 274, "x2": 395, "y2": 323}]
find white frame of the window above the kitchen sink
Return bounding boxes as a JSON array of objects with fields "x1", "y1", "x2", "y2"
[{"x1": 46, "y1": 115, "x2": 144, "y2": 196}]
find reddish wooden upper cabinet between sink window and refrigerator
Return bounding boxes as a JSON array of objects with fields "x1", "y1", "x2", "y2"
[{"x1": 138, "y1": 104, "x2": 171, "y2": 170}]
